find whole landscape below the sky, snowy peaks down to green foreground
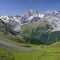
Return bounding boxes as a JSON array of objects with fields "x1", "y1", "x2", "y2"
[{"x1": 0, "y1": 10, "x2": 60, "y2": 60}]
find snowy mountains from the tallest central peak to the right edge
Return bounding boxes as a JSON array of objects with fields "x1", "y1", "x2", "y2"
[{"x1": 20, "y1": 10, "x2": 60, "y2": 31}]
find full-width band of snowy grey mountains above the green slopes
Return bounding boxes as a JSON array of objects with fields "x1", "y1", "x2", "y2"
[{"x1": 0, "y1": 10, "x2": 60, "y2": 31}]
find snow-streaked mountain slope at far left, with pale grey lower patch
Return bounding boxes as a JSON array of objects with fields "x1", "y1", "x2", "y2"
[{"x1": 0, "y1": 16, "x2": 21, "y2": 32}]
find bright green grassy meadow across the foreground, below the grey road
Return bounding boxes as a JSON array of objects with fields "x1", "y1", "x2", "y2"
[{"x1": 0, "y1": 44, "x2": 60, "y2": 60}]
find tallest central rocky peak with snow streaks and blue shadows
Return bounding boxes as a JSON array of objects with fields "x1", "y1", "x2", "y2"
[{"x1": 20, "y1": 10, "x2": 43, "y2": 24}]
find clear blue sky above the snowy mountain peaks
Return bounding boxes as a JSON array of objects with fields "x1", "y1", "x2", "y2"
[{"x1": 0, "y1": 0, "x2": 60, "y2": 15}]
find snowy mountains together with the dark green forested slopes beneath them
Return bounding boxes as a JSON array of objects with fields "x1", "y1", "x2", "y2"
[{"x1": 0, "y1": 10, "x2": 60, "y2": 44}]
